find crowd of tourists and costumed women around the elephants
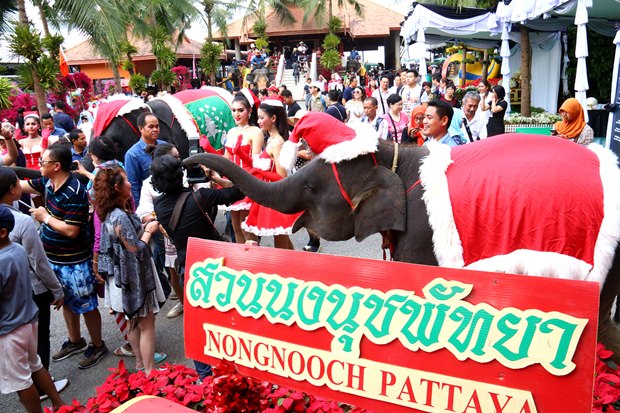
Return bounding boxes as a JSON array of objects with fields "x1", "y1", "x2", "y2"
[{"x1": 0, "y1": 44, "x2": 593, "y2": 411}]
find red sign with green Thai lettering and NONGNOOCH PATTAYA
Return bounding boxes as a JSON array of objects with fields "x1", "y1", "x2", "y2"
[{"x1": 185, "y1": 239, "x2": 599, "y2": 413}]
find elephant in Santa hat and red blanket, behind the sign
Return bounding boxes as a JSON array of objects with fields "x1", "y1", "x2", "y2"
[{"x1": 184, "y1": 112, "x2": 620, "y2": 356}]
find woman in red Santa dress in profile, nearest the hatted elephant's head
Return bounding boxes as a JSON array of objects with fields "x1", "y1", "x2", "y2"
[{"x1": 241, "y1": 99, "x2": 301, "y2": 250}]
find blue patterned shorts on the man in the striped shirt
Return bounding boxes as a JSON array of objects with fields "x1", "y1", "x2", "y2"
[{"x1": 50, "y1": 261, "x2": 98, "y2": 314}]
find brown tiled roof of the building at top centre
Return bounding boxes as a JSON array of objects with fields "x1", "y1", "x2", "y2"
[{"x1": 214, "y1": 0, "x2": 405, "y2": 43}]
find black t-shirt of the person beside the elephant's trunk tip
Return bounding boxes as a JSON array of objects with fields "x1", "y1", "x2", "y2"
[{"x1": 155, "y1": 187, "x2": 245, "y2": 262}]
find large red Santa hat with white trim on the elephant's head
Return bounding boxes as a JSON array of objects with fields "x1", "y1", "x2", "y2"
[{"x1": 279, "y1": 112, "x2": 379, "y2": 171}]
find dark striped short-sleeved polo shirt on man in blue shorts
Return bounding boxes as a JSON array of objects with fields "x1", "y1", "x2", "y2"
[{"x1": 28, "y1": 175, "x2": 91, "y2": 264}]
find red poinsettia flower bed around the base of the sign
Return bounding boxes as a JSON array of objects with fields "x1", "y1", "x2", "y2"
[{"x1": 45, "y1": 344, "x2": 620, "y2": 413}]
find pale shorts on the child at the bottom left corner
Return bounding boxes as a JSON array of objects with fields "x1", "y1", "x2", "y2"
[{"x1": 0, "y1": 321, "x2": 43, "y2": 394}]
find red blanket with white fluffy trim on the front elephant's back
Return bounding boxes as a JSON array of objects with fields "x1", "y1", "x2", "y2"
[{"x1": 421, "y1": 134, "x2": 619, "y2": 281}]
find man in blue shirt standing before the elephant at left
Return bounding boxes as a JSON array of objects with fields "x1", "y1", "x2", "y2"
[{"x1": 125, "y1": 112, "x2": 164, "y2": 205}]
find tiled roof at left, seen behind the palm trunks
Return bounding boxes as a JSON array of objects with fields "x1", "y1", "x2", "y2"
[{"x1": 65, "y1": 35, "x2": 202, "y2": 65}]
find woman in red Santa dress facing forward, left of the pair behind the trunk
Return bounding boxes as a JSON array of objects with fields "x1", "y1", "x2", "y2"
[{"x1": 224, "y1": 89, "x2": 265, "y2": 244}]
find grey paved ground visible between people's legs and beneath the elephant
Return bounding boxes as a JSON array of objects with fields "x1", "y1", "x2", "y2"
[{"x1": 0, "y1": 214, "x2": 382, "y2": 413}]
